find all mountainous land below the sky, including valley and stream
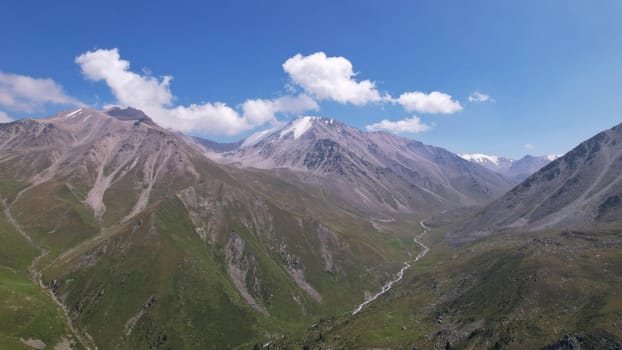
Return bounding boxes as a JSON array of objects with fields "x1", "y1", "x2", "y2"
[{"x1": 0, "y1": 108, "x2": 622, "y2": 349}]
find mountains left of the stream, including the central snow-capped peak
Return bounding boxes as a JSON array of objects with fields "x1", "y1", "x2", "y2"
[{"x1": 0, "y1": 108, "x2": 510, "y2": 348}]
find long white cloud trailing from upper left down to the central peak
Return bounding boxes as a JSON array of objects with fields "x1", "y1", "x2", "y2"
[{"x1": 76, "y1": 48, "x2": 319, "y2": 135}]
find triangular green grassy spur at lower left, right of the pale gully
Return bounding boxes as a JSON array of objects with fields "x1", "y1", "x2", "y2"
[{"x1": 44, "y1": 201, "x2": 266, "y2": 349}]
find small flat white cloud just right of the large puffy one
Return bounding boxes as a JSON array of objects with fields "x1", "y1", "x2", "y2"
[{"x1": 394, "y1": 91, "x2": 462, "y2": 114}]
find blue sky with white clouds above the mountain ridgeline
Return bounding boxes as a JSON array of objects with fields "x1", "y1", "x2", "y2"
[{"x1": 0, "y1": 0, "x2": 622, "y2": 157}]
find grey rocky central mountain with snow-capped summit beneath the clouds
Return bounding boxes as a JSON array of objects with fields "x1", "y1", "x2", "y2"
[{"x1": 197, "y1": 116, "x2": 513, "y2": 217}]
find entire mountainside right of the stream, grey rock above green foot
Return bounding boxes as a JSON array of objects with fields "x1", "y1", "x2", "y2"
[{"x1": 281, "y1": 124, "x2": 622, "y2": 350}]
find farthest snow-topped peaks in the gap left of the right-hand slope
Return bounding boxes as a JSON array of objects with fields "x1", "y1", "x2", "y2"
[{"x1": 458, "y1": 153, "x2": 559, "y2": 182}]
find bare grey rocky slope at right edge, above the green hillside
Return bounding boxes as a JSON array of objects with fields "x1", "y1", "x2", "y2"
[{"x1": 460, "y1": 120, "x2": 622, "y2": 238}]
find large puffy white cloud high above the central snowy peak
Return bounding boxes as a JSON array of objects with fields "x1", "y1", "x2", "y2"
[{"x1": 283, "y1": 52, "x2": 383, "y2": 106}]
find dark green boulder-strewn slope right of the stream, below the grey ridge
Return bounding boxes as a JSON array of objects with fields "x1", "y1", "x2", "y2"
[{"x1": 284, "y1": 226, "x2": 622, "y2": 349}]
